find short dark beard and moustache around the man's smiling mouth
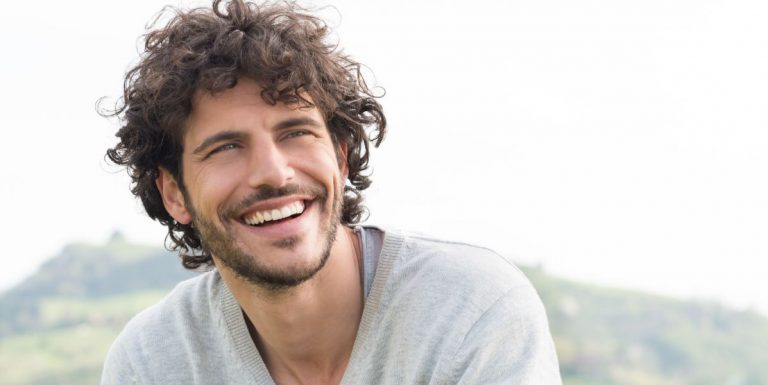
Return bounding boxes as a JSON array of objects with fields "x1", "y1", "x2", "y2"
[{"x1": 188, "y1": 185, "x2": 342, "y2": 292}]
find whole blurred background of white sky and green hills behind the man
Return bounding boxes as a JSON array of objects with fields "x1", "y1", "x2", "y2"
[{"x1": 0, "y1": 0, "x2": 768, "y2": 385}]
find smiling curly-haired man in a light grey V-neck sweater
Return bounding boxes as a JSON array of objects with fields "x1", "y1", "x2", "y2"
[{"x1": 102, "y1": 0, "x2": 560, "y2": 385}]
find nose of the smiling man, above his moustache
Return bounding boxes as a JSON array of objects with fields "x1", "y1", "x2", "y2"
[{"x1": 248, "y1": 140, "x2": 296, "y2": 188}]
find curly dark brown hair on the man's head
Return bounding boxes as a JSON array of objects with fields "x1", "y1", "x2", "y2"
[{"x1": 104, "y1": 0, "x2": 386, "y2": 269}]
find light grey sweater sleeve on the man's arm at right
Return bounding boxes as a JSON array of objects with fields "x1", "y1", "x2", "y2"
[{"x1": 449, "y1": 285, "x2": 562, "y2": 385}]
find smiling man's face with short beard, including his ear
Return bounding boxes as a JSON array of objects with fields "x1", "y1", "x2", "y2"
[{"x1": 158, "y1": 78, "x2": 347, "y2": 288}]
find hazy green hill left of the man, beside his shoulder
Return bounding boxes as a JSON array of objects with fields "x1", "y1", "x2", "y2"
[{"x1": 0, "y1": 234, "x2": 194, "y2": 385}]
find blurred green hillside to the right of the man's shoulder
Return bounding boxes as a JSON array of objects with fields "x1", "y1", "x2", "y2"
[{"x1": 525, "y1": 268, "x2": 768, "y2": 385}]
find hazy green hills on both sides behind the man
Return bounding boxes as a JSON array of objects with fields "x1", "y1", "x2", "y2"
[{"x1": 0, "y1": 234, "x2": 768, "y2": 385}]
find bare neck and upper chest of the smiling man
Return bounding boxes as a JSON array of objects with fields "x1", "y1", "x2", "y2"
[{"x1": 220, "y1": 226, "x2": 363, "y2": 384}]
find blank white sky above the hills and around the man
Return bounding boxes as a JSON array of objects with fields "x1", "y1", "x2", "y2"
[{"x1": 0, "y1": 0, "x2": 768, "y2": 313}]
